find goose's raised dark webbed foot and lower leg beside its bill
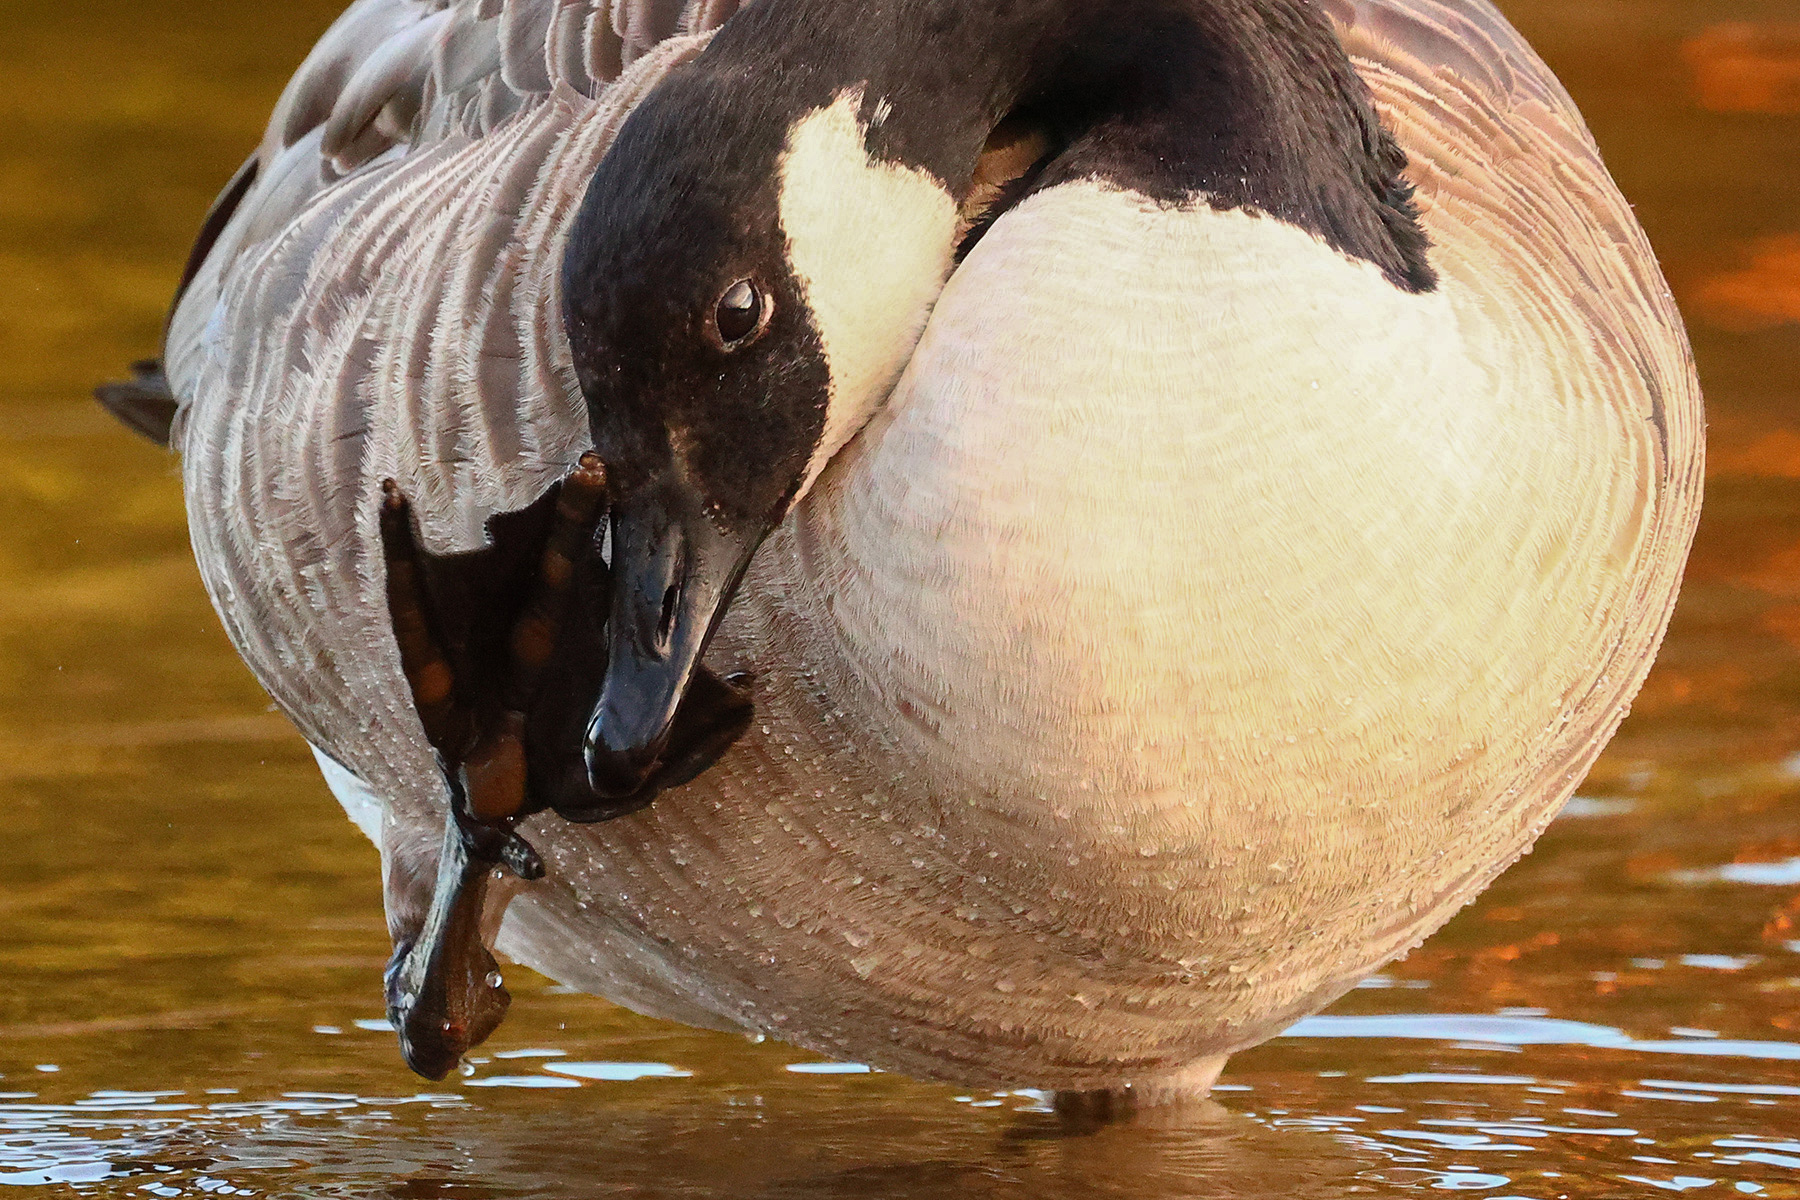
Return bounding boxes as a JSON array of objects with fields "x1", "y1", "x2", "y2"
[{"x1": 382, "y1": 453, "x2": 752, "y2": 1079}]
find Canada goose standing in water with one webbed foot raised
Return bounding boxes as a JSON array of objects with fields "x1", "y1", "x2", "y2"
[{"x1": 103, "y1": 0, "x2": 1701, "y2": 1096}]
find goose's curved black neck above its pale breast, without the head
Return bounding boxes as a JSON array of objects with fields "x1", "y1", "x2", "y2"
[{"x1": 702, "y1": 0, "x2": 1435, "y2": 291}]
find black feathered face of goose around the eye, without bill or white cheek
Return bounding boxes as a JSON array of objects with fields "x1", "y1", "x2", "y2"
[{"x1": 563, "y1": 65, "x2": 830, "y2": 524}]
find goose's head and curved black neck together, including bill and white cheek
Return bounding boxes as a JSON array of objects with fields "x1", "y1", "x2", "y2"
[{"x1": 563, "y1": 0, "x2": 1429, "y2": 795}]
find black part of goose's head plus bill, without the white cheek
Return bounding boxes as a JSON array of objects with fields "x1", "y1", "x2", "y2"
[{"x1": 563, "y1": 63, "x2": 830, "y2": 793}]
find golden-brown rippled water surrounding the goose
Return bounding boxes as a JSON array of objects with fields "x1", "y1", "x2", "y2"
[{"x1": 0, "y1": 0, "x2": 1800, "y2": 1200}]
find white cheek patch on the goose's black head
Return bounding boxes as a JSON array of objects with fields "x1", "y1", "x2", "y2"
[{"x1": 781, "y1": 88, "x2": 958, "y2": 491}]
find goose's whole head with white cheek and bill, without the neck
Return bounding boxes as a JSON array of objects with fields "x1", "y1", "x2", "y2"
[{"x1": 563, "y1": 70, "x2": 958, "y2": 795}]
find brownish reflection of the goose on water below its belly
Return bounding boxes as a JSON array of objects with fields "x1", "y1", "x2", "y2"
[{"x1": 197, "y1": 1081, "x2": 1389, "y2": 1200}]
